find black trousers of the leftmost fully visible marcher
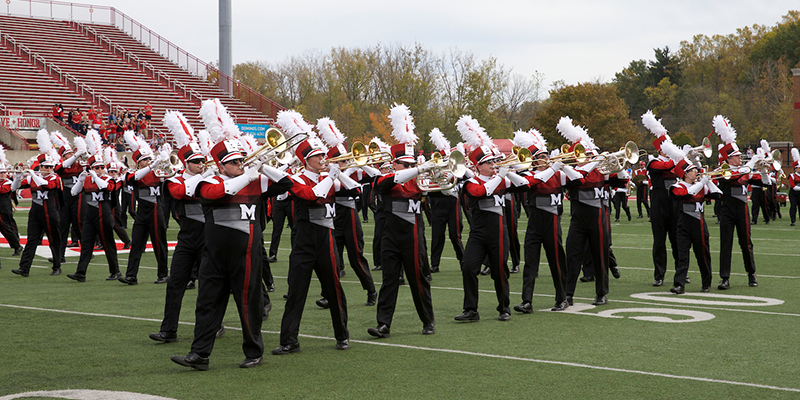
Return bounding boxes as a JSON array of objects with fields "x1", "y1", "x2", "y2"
[{"x1": 19, "y1": 203, "x2": 61, "y2": 272}]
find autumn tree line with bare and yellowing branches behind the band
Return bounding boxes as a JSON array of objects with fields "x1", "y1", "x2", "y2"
[{"x1": 233, "y1": 11, "x2": 800, "y2": 150}]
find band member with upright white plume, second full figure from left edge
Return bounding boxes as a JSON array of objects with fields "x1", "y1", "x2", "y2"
[{"x1": 67, "y1": 130, "x2": 122, "y2": 282}]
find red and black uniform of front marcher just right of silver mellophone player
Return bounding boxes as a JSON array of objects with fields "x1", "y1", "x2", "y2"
[{"x1": 461, "y1": 176, "x2": 527, "y2": 314}]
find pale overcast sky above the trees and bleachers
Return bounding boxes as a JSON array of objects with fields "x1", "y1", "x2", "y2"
[{"x1": 39, "y1": 0, "x2": 800, "y2": 94}]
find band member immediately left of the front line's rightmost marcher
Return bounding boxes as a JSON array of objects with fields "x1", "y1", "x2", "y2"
[{"x1": 514, "y1": 129, "x2": 569, "y2": 314}]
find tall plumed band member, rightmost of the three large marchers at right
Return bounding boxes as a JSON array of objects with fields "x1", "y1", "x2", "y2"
[{"x1": 713, "y1": 115, "x2": 759, "y2": 290}]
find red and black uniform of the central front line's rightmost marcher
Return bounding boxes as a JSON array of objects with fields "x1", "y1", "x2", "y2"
[{"x1": 565, "y1": 167, "x2": 610, "y2": 300}]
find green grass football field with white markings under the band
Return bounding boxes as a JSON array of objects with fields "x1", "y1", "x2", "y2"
[{"x1": 0, "y1": 202, "x2": 800, "y2": 399}]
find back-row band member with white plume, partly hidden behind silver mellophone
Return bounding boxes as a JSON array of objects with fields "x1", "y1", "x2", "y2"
[{"x1": 427, "y1": 128, "x2": 464, "y2": 273}]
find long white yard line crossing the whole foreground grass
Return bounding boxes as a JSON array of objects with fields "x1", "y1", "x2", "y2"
[{"x1": 0, "y1": 304, "x2": 800, "y2": 393}]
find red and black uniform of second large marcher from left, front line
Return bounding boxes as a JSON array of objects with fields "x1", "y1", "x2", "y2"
[{"x1": 280, "y1": 170, "x2": 350, "y2": 346}]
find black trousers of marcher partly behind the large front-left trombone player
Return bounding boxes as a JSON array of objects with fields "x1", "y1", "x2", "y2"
[{"x1": 161, "y1": 216, "x2": 206, "y2": 332}]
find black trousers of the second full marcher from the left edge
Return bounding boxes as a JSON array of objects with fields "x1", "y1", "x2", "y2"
[{"x1": 76, "y1": 201, "x2": 119, "y2": 276}]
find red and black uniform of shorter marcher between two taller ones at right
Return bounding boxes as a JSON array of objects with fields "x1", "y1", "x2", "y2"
[{"x1": 670, "y1": 181, "x2": 720, "y2": 289}]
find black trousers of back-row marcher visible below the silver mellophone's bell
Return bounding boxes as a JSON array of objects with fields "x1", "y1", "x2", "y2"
[{"x1": 428, "y1": 196, "x2": 464, "y2": 267}]
